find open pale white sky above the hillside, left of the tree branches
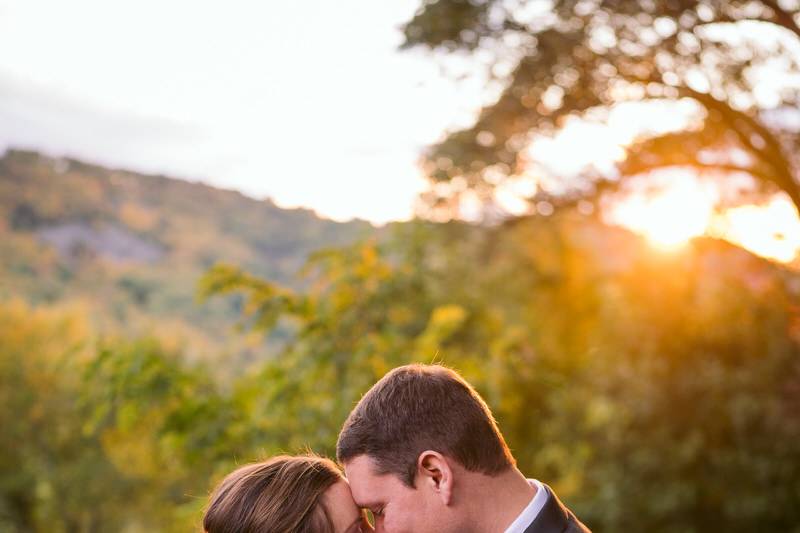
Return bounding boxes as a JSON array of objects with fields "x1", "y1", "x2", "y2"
[{"x1": 0, "y1": 0, "x2": 483, "y2": 224}]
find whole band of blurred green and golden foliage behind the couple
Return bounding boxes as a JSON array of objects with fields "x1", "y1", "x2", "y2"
[{"x1": 0, "y1": 210, "x2": 800, "y2": 533}]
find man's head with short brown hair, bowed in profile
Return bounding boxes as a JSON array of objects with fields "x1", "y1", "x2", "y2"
[{"x1": 336, "y1": 365, "x2": 514, "y2": 532}]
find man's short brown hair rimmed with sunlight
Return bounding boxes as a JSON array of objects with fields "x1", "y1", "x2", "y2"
[{"x1": 336, "y1": 365, "x2": 515, "y2": 487}]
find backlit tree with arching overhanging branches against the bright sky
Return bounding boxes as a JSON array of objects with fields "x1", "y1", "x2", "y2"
[{"x1": 403, "y1": 0, "x2": 800, "y2": 216}]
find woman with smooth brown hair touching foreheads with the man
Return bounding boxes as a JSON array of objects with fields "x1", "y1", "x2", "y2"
[{"x1": 203, "y1": 455, "x2": 372, "y2": 533}]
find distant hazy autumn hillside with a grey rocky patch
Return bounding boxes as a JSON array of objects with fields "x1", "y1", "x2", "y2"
[{"x1": 0, "y1": 150, "x2": 375, "y2": 362}]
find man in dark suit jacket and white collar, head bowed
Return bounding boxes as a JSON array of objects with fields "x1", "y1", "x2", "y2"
[{"x1": 336, "y1": 365, "x2": 589, "y2": 533}]
